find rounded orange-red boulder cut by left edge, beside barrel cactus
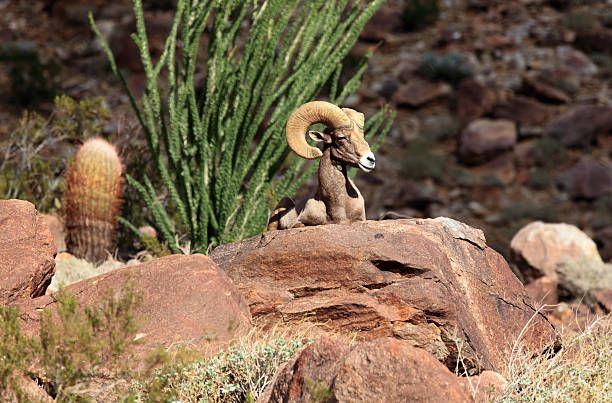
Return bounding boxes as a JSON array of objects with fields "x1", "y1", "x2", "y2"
[{"x1": 0, "y1": 200, "x2": 56, "y2": 304}]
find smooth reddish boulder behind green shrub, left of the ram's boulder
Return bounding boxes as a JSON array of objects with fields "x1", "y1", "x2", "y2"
[{"x1": 19, "y1": 255, "x2": 251, "y2": 357}]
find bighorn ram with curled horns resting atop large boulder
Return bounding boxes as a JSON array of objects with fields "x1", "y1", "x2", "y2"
[{"x1": 268, "y1": 101, "x2": 376, "y2": 230}]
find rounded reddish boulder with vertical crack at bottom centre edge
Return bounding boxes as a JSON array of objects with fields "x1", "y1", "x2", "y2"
[{"x1": 258, "y1": 338, "x2": 473, "y2": 403}]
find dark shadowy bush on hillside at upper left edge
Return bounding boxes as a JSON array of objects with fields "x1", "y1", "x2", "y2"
[{"x1": 0, "y1": 42, "x2": 57, "y2": 107}]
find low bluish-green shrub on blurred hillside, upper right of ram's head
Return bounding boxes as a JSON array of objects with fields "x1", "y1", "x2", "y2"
[{"x1": 417, "y1": 52, "x2": 474, "y2": 85}]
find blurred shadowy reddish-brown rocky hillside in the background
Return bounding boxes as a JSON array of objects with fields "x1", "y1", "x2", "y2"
[{"x1": 0, "y1": 0, "x2": 612, "y2": 260}]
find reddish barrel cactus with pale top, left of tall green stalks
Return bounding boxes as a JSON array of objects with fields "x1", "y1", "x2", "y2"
[{"x1": 64, "y1": 138, "x2": 122, "y2": 263}]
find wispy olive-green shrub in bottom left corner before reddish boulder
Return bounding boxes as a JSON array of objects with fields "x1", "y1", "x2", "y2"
[{"x1": 0, "y1": 281, "x2": 142, "y2": 402}]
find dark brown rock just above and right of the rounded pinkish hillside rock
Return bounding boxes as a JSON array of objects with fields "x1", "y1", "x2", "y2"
[{"x1": 493, "y1": 96, "x2": 554, "y2": 136}]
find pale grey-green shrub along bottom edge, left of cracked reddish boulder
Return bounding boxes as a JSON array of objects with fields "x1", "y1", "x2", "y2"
[{"x1": 132, "y1": 332, "x2": 313, "y2": 403}]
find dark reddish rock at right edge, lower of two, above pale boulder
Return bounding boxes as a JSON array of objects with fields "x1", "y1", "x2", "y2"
[{"x1": 559, "y1": 158, "x2": 612, "y2": 200}]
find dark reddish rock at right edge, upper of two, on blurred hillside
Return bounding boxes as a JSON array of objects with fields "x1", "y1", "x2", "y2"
[{"x1": 545, "y1": 105, "x2": 612, "y2": 147}]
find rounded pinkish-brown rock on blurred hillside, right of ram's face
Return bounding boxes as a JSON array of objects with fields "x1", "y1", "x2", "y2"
[{"x1": 459, "y1": 119, "x2": 517, "y2": 164}]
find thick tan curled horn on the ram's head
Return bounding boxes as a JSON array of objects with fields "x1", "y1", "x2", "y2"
[{"x1": 285, "y1": 101, "x2": 352, "y2": 160}]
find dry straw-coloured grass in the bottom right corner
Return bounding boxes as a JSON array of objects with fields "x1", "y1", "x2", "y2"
[{"x1": 497, "y1": 315, "x2": 612, "y2": 402}]
